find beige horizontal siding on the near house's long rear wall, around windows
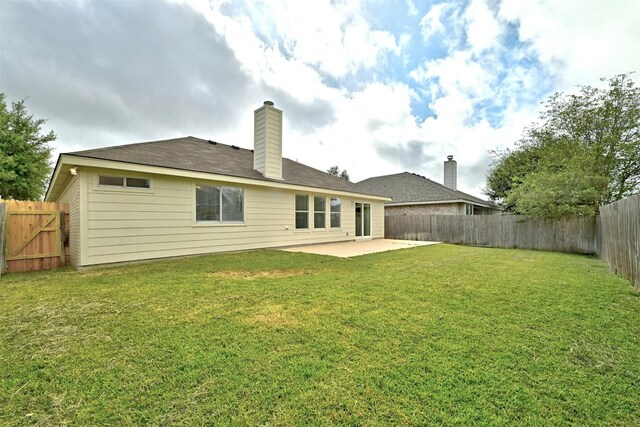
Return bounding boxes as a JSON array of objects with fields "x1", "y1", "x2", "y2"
[{"x1": 77, "y1": 171, "x2": 384, "y2": 265}]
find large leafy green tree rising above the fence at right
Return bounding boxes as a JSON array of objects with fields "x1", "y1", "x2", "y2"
[{"x1": 485, "y1": 74, "x2": 640, "y2": 217}]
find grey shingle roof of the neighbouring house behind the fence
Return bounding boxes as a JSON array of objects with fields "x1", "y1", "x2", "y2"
[{"x1": 355, "y1": 172, "x2": 498, "y2": 208}]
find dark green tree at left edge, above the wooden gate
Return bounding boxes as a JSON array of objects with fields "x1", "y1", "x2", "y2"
[{"x1": 0, "y1": 93, "x2": 56, "y2": 200}]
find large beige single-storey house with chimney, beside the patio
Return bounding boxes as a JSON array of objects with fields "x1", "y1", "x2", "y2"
[{"x1": 45, "y1": 101, "x2": 389, "y2": 268}]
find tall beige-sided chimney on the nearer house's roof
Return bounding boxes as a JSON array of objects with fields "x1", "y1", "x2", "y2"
[{"x1": 253, "y1": 101, "x2": 282, "y2": 179}]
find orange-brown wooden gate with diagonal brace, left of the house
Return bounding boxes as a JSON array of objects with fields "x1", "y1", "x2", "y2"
[{"x1": 0, "y1": 200, "x2": 69, "y2": 273}]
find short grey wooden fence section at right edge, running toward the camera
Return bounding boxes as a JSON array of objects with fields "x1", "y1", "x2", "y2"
[{"x1": 600, "y1": 194, "x2": 640, "y2": 290}]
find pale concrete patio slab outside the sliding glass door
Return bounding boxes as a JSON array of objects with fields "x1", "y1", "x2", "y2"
[{"x1": 282, "y1": 239, "x2": 440, "y2": 258}]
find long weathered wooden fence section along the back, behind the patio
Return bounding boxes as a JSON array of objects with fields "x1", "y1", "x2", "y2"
[{"x1": 385, "y1": 215, "x2": 600, "y2": 254}]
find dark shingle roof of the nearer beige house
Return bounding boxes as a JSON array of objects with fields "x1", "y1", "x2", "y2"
[{"x1": 65, "y1": 136, "x2": 370, "y2": 194}]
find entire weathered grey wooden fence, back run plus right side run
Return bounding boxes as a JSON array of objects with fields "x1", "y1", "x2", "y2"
[{"x1": 385, "y1": 194, "x2": 640, "y2": 290}]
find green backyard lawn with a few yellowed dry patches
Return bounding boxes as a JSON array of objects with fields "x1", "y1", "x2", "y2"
[{"x1": 0, "y1": 245, "x2": 640, "y2": 426}]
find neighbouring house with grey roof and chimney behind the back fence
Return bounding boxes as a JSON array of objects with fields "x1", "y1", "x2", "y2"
[{"x1": 356, "y1": 156, "x2": 501, "y2": 216}]
